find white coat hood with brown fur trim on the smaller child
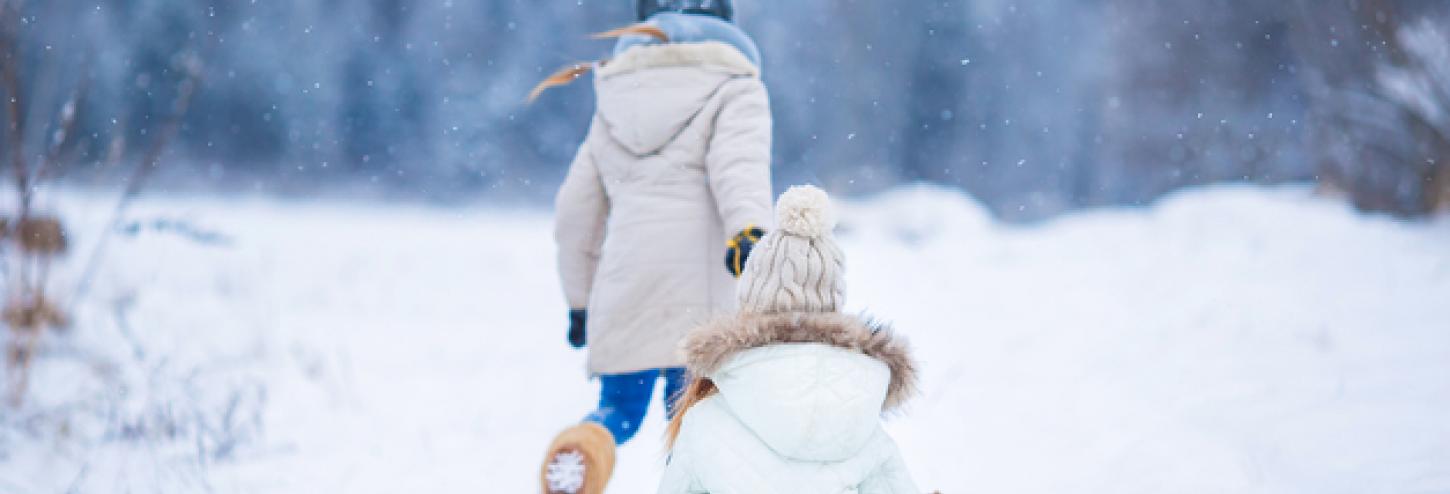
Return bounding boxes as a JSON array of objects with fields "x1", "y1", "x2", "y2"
[{"x1": 684, "y1": 313, "x2": 916, "y2": 462}]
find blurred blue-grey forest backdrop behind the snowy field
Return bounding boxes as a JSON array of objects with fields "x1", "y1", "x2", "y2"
[{"x1": 8, "y1": 0, "x2": 1450, "y2": 220}]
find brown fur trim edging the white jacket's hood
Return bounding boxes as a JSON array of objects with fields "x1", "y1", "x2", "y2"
[{"x1": 682, "y1": 313, "x2": 916, "y2": 411}]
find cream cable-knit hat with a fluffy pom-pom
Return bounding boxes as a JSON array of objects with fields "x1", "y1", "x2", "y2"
[{"x1": 737, "y1": 185, "x2": 845, "y2": 313}]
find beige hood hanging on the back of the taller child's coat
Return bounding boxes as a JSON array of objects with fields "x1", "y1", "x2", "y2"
[{"x1": 595, "y1": 41, "x2": 760, "y2": 156}]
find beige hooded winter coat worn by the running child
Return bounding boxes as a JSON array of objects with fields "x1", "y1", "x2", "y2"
[{"x1": 555, "y1": 42, "x2": 771, "y2": 374}]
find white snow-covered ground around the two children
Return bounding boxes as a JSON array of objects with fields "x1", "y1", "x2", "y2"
[{"x1": 0, "y1": 182, "x2": 1450, "y2": 493}]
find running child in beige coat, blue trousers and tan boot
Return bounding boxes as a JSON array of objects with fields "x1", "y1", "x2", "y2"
[{"x1": 534, "y1": 0, "x2": 771, "y2": 493}]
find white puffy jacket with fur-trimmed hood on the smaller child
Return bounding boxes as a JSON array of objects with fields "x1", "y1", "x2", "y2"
[{"x1": 660, "y1": 313, "x2": 919, "y2": 494}]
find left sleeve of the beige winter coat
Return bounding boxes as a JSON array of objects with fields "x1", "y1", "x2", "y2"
[{"x1": 554, "y1": 120, "x2": 609, "y2": 309}]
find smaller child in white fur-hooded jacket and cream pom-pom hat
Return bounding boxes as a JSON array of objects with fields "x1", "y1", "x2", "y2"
[{"x1": 660, "y1": 187, "x2": 919, "y2": 494}]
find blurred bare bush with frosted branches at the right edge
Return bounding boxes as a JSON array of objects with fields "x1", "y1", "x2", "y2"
[{"x1": 1293, "y1": 0, "x2": 1450, "y2": 216}]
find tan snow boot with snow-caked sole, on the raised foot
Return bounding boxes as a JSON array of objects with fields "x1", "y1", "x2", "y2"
[{"x1": 539, "y1": 422, "x2": 615, "y2": 494}]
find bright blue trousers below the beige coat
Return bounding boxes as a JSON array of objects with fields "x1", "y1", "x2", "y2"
[{"x1": 584, "y1": 367, "x2": 686, "y2": 445}]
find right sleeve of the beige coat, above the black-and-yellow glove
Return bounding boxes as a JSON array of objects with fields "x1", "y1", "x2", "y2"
[{"x1": 705, "y1": 77, "x2": 771, "y2": 238}]
